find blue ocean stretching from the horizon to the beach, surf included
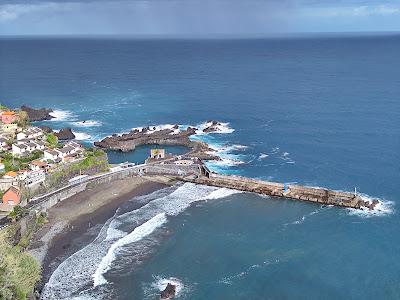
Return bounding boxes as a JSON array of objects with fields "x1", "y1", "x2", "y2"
[{"x1": 0, "y1": 35, "x2": 400, "y2": 299}]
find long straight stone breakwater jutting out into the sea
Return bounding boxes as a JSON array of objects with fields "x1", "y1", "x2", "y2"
[{"x1": 180, "y1": 174, "x2": 379, "y2": 210}]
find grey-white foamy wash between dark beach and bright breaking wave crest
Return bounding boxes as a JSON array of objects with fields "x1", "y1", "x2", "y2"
[{"x1": 42, "y1": 183, "x2": 239, "y2": 299}]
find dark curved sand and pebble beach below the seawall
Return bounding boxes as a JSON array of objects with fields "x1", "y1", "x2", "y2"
[{"x1": 29, "y1": 177, "x2": 171, "y2": 291}]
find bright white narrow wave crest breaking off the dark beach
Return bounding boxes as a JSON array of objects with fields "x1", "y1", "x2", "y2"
[{"x1": 93, "y1": 213, "x2": 167, "y2": 286}]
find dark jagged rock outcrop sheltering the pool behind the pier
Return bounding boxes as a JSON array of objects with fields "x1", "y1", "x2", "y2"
[{"x1": 94, "y1": 121, "x2": 225, "y2": 160}]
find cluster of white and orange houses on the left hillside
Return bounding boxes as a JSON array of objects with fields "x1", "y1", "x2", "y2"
[{"x1": 0, "y1": 111, "x2": 84, "y2": 210}]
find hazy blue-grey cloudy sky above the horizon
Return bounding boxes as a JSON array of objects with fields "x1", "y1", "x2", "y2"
[{"x1": 0, "y1": 0, "x2": 400, "y2": 36}]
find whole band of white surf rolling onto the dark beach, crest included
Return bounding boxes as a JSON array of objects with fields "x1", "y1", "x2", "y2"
[{"x1": 42, "y1": 183, "x2": 240, "y2": 299}]
